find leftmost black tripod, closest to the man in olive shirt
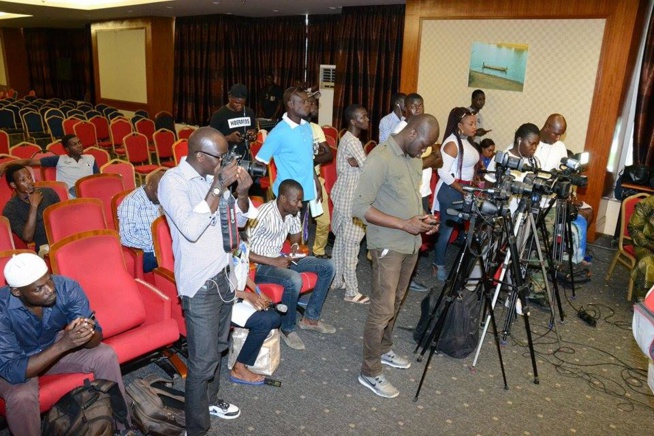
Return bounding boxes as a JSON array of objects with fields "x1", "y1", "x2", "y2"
[{"x1": 413, "y1": 205, "x2": 508, "y2": 401}]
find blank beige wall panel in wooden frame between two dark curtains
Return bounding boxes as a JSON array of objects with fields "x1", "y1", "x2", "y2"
[{"x1": 97, "y1": 28, "x2": 148, "y2": 103}]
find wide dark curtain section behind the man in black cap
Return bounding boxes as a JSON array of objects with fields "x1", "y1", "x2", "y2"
[{"x1": 173, "y1": 15, "x2": 306, "y2": 125}]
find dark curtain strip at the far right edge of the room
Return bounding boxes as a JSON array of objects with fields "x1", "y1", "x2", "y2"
[{"x1": 633, "y1": 14, "x2": 654, "y2": 167}]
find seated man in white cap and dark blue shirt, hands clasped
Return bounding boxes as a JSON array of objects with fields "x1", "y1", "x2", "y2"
[{"x1": 0, "y1": 253, "x2": 125, "y2": 435}]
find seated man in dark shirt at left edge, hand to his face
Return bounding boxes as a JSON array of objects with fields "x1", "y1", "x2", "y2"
[{"x1": 2, "y1": 164, "x2": 60, "y2": 251}]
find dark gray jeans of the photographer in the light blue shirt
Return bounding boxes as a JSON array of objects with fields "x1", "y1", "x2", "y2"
[{"x1": 182, "y1": 271, "x2": 234, "y2": 436}]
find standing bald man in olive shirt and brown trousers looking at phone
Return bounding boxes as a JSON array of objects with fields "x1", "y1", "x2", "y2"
[{"x1": 352, "y1": 115, "x2": 439, "y2": 398}]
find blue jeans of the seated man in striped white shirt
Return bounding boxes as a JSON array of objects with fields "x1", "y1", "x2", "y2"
[{"x1": 254, "y1": 256, "x2": 334, "y2": 334}]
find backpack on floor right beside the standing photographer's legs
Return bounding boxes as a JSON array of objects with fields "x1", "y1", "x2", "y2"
[{"x1": 127, "y1": 374, "x2": 186, "y2": 436}]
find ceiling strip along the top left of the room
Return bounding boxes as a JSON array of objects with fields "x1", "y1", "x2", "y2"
[{"x1": 0, "y1": 0, "x2": 405, "y2": 28}]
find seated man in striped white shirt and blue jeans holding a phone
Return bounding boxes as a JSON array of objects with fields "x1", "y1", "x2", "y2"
[{"x1": 250, "y1": 179, "x2": 336, "y2": 350}]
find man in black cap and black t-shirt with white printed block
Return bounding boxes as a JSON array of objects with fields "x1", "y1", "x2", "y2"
[{"x1": 209, "y1": 83, "x2": 257, "y2": 159}]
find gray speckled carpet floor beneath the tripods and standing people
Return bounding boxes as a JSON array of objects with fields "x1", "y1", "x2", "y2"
[{"x1": 126, "y1": 238, "x2": 654, "y2": 435}]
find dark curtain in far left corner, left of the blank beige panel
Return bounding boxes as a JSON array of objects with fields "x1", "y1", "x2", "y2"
[{"x1": 23, "y1": 29, "x2": 93, "y2": 101}]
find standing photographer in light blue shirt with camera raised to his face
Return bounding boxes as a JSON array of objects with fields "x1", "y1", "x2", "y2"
[{"x1": 159, "y1": 127, "x2": 256, "y2": 436}]
